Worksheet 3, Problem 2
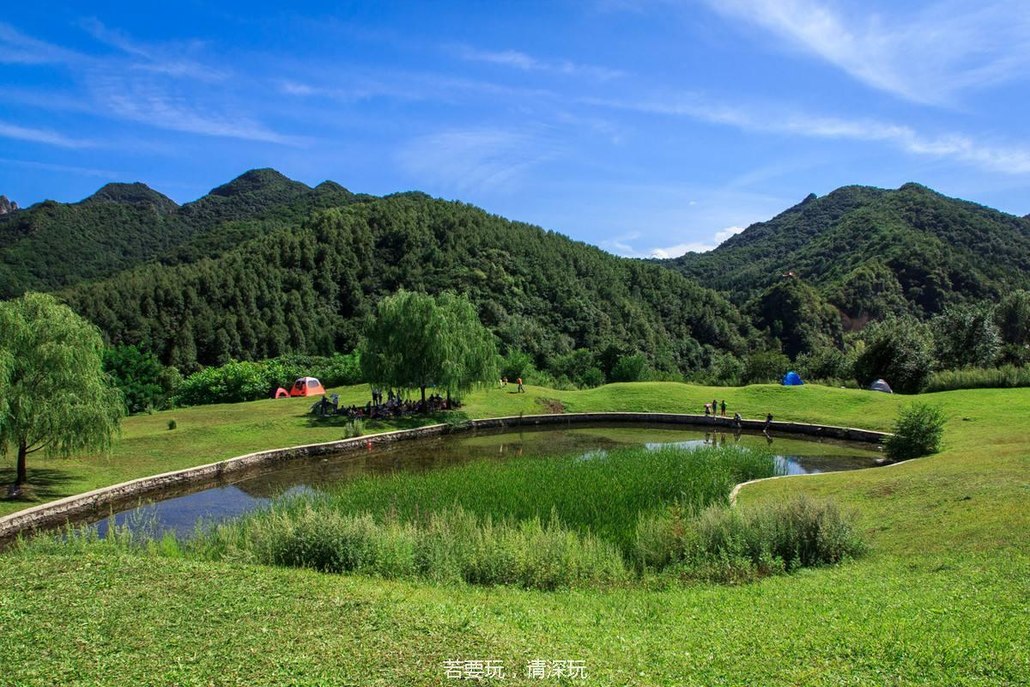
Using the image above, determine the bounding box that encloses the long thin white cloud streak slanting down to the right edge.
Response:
[585,94,1030,174]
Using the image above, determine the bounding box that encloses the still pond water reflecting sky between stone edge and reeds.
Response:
[91,424,881,537]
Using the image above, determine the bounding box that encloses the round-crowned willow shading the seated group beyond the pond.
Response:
[358,290,496,403]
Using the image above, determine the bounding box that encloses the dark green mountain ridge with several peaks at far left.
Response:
[0,170,355,298]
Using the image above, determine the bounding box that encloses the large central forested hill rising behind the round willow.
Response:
[61,194,753,371]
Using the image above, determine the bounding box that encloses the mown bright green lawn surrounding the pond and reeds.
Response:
[0,384,1030,685]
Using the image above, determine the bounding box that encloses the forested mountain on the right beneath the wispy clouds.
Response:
[663,183,1030,325]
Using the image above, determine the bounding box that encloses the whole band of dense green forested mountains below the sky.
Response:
[0,169,1030,407]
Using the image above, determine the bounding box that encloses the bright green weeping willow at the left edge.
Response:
[0,294,125,492]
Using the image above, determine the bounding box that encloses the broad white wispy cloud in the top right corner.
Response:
[706,0,1030,104]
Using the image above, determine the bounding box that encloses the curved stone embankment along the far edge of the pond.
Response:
[0,412,886,545]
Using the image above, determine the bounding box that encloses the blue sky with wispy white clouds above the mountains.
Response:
[0,0,1030,255]
